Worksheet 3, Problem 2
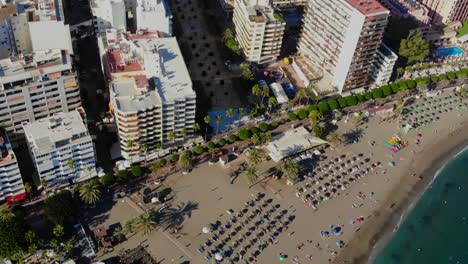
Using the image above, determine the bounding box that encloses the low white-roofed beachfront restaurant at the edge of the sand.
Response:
[267,127,327,162]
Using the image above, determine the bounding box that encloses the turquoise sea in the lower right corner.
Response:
[373,146,468,264]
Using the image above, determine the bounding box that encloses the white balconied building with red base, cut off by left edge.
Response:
[0,131,25,202]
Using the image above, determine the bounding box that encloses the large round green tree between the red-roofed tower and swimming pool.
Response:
[398,29,431,63]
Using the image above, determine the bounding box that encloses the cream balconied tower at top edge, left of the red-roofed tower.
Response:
[233,0,286,64]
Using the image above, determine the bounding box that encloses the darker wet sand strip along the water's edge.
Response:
[333,120,468,264]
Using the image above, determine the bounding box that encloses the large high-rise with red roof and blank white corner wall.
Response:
[298,0,390,93]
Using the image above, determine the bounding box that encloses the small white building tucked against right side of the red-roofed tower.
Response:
[372,43,398,86]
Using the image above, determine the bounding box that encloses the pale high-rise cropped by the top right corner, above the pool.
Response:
[417,0,468,24]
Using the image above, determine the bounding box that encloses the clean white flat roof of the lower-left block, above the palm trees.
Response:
[23,110,91,153]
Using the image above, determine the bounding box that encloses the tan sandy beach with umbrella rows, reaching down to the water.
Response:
[91,88,468,263]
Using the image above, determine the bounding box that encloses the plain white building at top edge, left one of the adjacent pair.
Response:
[90,0,127,32]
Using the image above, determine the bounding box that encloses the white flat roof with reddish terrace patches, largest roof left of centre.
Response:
[108,34,196,112]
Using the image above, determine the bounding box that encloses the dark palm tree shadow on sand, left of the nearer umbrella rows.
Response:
[157,201,198,230]
